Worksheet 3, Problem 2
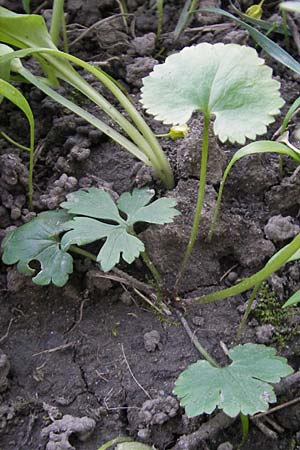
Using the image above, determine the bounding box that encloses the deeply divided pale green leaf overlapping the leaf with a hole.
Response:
[61,188,179,272]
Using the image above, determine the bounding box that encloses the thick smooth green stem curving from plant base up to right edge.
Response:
[184,234,300,305]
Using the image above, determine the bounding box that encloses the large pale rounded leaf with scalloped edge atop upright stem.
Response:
[141,43,284,144]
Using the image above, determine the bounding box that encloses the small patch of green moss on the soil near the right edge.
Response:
[253,283,299,347]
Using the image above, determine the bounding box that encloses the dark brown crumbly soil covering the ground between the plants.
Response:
[0,0,300,450]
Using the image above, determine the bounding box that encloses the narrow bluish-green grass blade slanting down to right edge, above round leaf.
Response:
[199,8,300,73]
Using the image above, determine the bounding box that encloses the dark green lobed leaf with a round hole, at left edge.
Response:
[2,211,73,287]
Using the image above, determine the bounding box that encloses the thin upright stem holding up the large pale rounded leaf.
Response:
[174,113,210,297]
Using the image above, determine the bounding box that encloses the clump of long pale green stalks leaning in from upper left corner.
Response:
[0,7,174,188]
